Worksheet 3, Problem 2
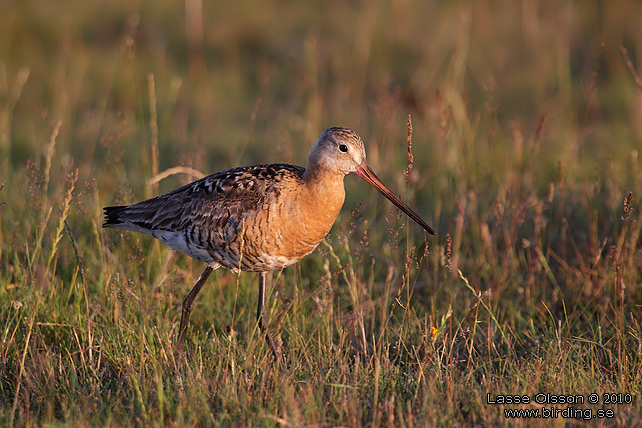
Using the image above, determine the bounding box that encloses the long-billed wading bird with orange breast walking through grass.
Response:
[102,127,435,364]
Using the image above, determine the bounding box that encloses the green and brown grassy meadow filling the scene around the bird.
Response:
[0,0,642,426]
